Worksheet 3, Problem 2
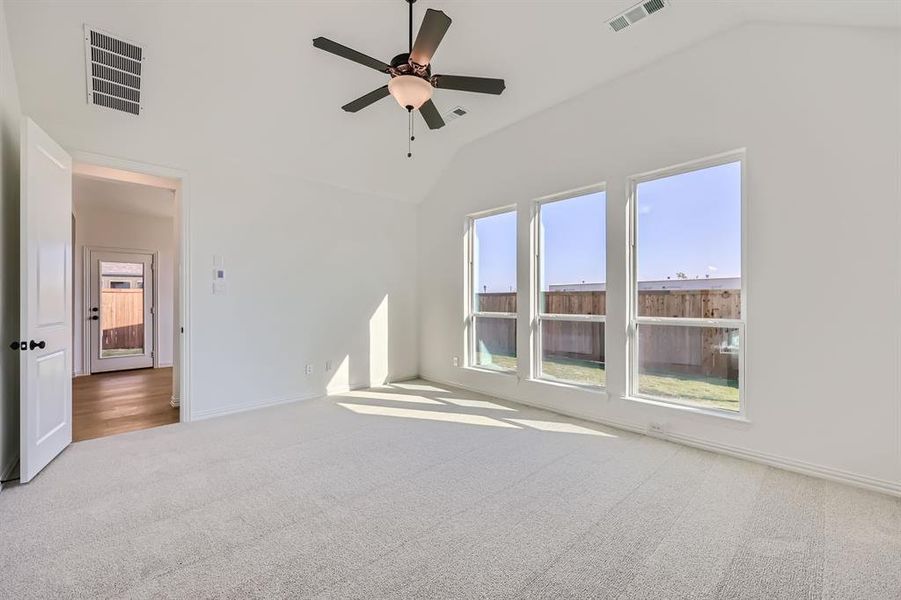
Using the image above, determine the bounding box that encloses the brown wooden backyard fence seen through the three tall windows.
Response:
[477,290,741,379]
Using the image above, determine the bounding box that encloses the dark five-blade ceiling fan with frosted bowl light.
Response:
[313,0,505,157]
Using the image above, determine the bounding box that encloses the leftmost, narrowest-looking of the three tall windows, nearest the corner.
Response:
[468,208,516,371]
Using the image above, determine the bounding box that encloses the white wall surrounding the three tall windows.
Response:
[419,24,901,491]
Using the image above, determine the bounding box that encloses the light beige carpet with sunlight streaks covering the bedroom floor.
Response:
[0,382,901,600]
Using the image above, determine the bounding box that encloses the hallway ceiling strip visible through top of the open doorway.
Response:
[72,175,175,219]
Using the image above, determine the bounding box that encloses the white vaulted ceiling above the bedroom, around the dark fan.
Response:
[6,0,901,201]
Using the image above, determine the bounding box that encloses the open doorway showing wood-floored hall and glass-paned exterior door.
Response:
[72,162,182,442]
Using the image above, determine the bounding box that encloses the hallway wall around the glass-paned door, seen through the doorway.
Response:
[73,199,175,374]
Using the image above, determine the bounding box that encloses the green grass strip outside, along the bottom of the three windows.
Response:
[479,353,738,411]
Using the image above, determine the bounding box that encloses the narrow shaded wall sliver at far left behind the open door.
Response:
[0,0,22,486]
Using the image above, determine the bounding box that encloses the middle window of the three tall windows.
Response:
[535,187,607,386]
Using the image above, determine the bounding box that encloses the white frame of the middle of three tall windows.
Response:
[531,182,609,391]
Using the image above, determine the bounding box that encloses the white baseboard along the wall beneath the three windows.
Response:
[421,374,901,497]
